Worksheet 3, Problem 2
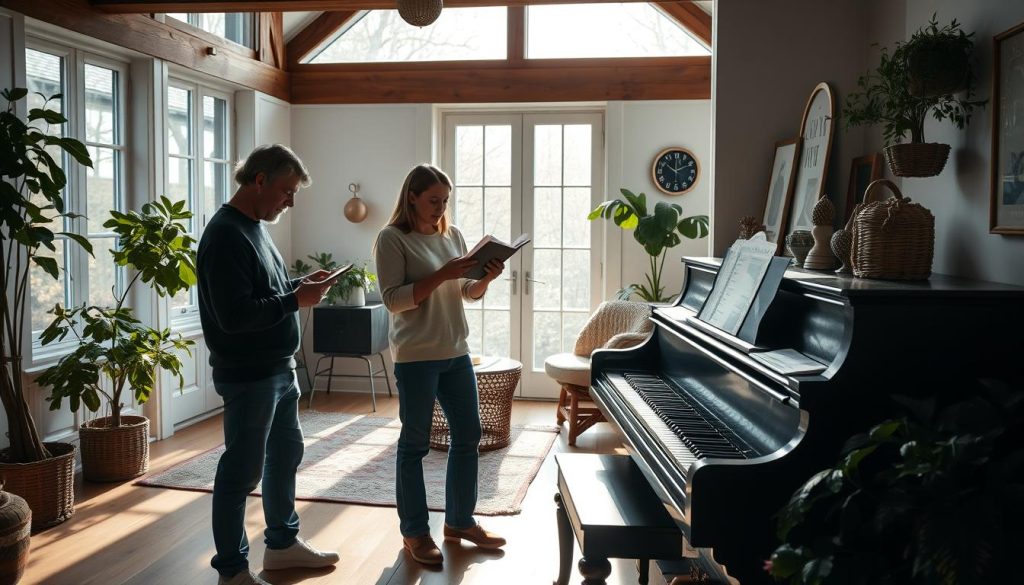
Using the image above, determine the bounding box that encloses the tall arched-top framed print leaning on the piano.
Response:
[785,82,836,235]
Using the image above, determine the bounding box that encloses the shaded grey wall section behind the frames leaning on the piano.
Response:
[712,0,869,255]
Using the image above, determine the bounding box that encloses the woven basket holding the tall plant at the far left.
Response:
[0,443,75,531]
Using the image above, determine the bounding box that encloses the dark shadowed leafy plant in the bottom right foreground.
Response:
[766,381,1024,585]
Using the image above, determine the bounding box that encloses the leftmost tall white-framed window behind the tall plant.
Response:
[26,39,127,350]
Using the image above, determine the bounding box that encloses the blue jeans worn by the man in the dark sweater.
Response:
[210,371,303,577]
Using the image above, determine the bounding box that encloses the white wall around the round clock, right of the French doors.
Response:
[604,99,712,298]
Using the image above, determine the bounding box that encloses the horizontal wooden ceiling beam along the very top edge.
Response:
[90,0,703,13]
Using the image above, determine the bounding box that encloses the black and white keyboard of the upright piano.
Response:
[605,372,755,469]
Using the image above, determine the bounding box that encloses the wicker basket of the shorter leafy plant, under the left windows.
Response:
[78,416,150,482]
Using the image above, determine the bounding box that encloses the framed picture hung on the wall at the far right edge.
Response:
[988,23,1024,236]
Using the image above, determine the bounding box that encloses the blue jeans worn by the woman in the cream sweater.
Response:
[394,356,480,536]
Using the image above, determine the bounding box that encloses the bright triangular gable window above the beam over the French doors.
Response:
[303,2,711,64]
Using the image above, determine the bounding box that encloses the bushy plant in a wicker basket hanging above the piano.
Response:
[843,18,986,177]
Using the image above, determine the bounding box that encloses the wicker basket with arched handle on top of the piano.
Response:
[850,179,935,281]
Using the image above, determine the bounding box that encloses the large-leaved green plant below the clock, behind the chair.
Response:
[587,189,709,302]
